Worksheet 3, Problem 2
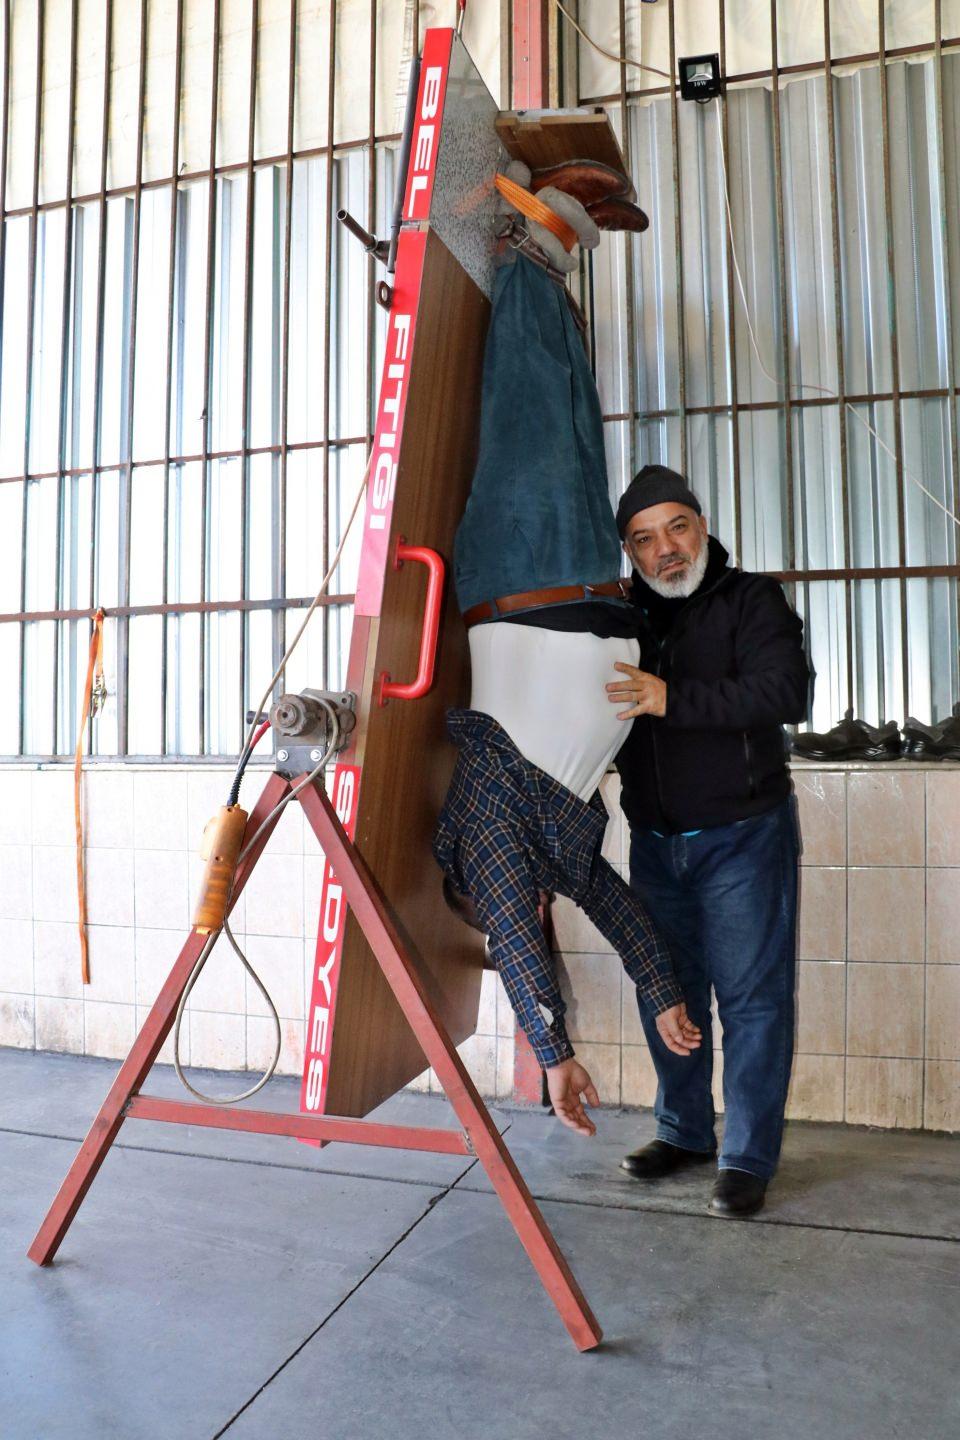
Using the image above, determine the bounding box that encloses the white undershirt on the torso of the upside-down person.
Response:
[469,621,640,801]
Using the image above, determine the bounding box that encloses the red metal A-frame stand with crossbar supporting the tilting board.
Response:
[27,775,602,1351]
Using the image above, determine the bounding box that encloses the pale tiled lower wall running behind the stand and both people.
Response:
[0,766,960,1130]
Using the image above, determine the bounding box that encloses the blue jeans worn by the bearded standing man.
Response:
[630,798,799,1179]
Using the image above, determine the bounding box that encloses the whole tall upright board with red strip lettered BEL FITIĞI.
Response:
[301,29,502,1117]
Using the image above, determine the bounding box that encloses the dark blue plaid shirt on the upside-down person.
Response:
[433,710,682,1067]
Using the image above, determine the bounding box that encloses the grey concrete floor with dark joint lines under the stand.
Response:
[0,1050,960,1440]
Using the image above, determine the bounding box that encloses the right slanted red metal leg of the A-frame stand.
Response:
[298,785,602,1351]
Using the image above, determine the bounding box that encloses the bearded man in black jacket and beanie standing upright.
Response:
[607,465,809,1215]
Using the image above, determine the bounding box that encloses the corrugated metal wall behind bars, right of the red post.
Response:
[592,32,960,729]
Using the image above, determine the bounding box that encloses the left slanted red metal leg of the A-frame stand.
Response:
[27,775,289,1264]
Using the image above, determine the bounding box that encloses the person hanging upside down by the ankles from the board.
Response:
[433,151,701,1135]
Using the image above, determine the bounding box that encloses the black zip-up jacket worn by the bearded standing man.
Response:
[616,536,810,834]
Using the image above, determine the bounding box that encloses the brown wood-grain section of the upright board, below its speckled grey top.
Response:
[315,230,489,1116]
